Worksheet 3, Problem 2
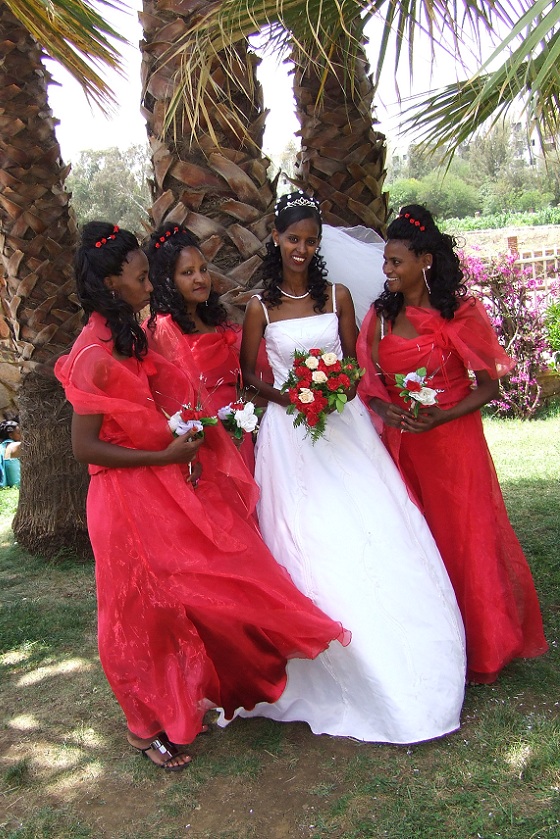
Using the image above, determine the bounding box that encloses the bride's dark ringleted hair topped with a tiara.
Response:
[261,192,328,312]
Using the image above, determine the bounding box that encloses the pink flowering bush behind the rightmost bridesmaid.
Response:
[461,253,550,419]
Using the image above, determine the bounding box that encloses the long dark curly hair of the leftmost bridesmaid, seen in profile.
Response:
[74,221,148,360]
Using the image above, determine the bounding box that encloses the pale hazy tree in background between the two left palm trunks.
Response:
[66,144,152,236]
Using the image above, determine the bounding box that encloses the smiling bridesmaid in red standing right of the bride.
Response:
[358,205,547,683]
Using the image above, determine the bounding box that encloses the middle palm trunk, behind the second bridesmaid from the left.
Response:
[140,0,275,296]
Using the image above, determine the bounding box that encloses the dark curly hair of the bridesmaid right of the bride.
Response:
[374,204,467,322]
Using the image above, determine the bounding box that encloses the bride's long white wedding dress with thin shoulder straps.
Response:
[230,290,465,743]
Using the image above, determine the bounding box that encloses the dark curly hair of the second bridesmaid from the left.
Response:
[144,222,228,335]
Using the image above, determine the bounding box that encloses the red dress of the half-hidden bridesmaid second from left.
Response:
[146,315,272,474]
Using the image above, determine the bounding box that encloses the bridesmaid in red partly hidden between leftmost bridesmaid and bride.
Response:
[145,223,272,474]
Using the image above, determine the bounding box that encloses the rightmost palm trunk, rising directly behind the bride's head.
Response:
[292,49,389,235]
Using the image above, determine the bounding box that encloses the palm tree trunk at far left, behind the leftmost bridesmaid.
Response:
[0,2,89,556]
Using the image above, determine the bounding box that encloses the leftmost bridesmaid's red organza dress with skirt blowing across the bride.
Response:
[55,315,348,743]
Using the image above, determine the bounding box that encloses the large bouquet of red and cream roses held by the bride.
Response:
[281,349,364,443]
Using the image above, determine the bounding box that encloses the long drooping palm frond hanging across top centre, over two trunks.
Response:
[158,0,516,143]
